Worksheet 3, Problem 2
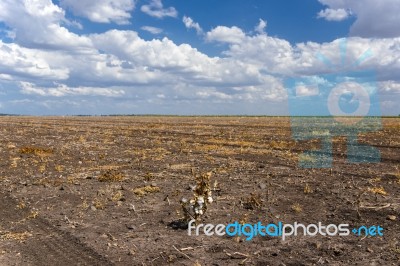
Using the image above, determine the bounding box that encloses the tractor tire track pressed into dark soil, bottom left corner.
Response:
[0,192,113,265]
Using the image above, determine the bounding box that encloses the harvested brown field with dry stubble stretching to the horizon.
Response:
[0,117,400,265]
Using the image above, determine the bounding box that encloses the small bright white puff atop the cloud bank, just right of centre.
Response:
[206,26,246,43]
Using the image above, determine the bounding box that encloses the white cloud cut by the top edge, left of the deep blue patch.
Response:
[60,0,135,24]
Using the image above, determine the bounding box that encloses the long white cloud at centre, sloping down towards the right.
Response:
[91,30,261,86]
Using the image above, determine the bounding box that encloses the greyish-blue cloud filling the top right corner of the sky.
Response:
[319,0,400,38]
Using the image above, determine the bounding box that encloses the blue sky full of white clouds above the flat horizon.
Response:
[0,0,400,115]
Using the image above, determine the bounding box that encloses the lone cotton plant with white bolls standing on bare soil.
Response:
[181,172,213,222]
